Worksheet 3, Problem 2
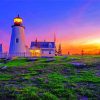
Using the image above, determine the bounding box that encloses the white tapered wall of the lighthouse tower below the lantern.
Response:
[9,26,26,54]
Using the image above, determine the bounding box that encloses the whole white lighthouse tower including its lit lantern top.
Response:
[9,15,26,56]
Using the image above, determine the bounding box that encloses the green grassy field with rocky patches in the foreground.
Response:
[0,56,100,100]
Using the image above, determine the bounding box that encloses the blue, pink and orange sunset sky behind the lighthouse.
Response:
[0,0,100,53]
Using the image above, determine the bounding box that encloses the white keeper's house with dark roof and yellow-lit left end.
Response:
[30,41,55,57]
